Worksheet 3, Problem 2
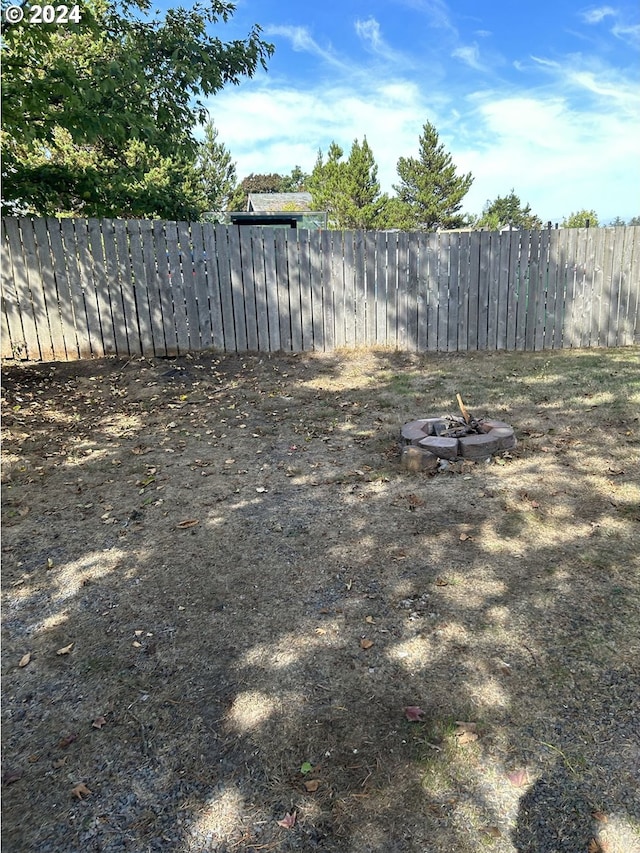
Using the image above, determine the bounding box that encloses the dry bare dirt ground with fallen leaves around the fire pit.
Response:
[2,348,640,853]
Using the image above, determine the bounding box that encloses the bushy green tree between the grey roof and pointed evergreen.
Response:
[308,137,388,230]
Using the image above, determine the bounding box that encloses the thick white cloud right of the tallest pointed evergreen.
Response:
[456,93,640,222]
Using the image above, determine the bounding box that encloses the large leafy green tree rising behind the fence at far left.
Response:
[2,0,273,218]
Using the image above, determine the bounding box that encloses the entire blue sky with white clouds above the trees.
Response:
[198,0,640,223]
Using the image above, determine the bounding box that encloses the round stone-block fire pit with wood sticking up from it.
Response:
[400,394,517,471]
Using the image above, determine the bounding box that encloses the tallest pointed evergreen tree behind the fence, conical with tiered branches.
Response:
[394,122,473,231]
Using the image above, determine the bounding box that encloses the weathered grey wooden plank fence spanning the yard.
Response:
[2,218,640,361]
